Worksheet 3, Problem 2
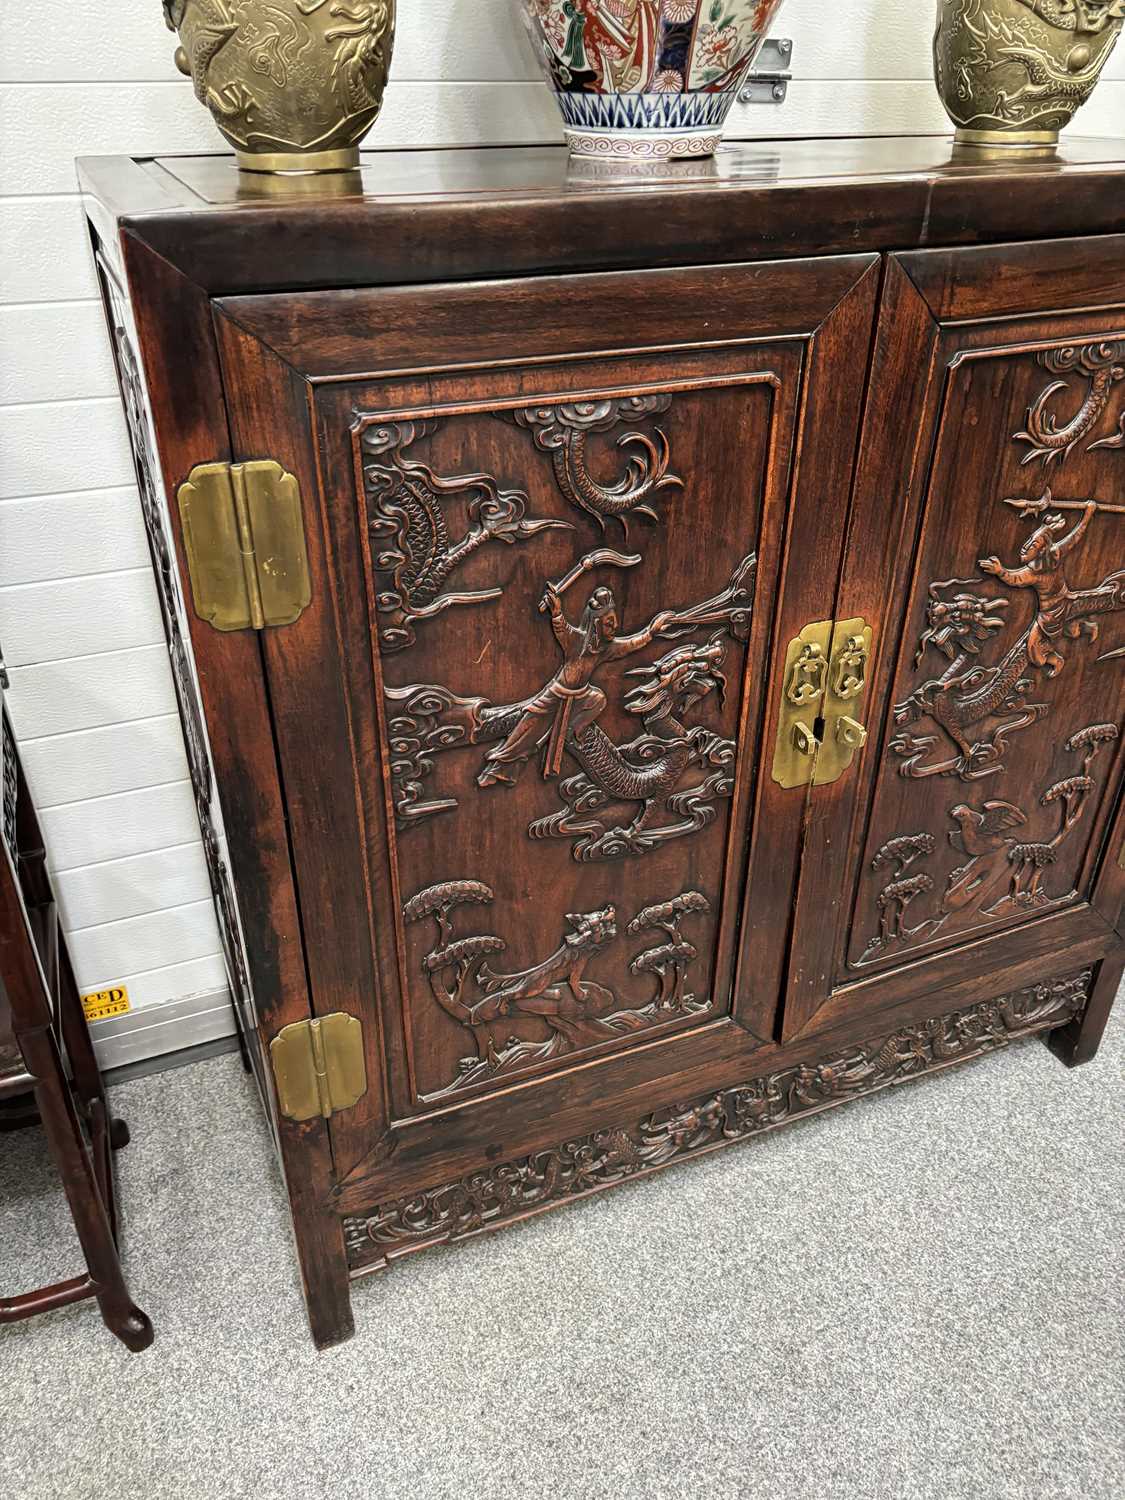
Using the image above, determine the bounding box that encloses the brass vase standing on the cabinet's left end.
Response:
[164,0,395,173]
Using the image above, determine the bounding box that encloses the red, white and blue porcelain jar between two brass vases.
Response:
[519,0,782,159]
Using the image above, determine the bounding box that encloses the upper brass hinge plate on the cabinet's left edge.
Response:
[176,459,312,630]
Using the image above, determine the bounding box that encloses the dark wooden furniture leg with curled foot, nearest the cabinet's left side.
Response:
[21,1031,153,1353]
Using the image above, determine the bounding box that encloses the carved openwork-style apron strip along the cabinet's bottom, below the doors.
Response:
[344,969,1092,1269]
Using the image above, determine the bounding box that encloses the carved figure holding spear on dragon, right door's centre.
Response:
[891,489,1125,782]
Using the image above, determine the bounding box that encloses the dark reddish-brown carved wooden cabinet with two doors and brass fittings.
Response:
[84,141,1125,1343]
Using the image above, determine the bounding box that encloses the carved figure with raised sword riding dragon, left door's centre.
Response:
[384,548,756,860]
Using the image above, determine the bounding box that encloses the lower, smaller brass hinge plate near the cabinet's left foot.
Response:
[270,1011,368,1121]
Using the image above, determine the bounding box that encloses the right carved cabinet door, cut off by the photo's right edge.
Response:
[783,237,1125,1038]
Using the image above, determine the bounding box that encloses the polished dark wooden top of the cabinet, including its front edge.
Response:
[78,135,1125,291]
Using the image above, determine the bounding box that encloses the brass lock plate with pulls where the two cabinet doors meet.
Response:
[774,620,872,788]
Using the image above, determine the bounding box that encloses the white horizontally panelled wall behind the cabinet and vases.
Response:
[0,0,1125,1047]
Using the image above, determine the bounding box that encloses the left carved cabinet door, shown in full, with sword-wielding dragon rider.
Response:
[216,257,879,1206]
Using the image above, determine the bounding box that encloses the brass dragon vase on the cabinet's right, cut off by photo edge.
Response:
[933,0,1125,150]
